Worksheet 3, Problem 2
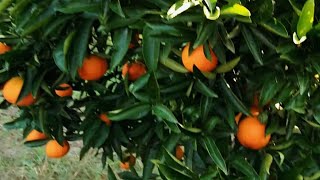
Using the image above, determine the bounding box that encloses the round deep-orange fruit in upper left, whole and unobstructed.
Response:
[78,55,108,81]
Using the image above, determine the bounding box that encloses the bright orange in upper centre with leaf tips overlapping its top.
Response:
[182,43,218,72]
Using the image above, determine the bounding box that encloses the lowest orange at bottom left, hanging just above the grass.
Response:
[46,140,70,158]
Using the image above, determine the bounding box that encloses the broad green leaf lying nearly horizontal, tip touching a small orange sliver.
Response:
[108,103,151,121]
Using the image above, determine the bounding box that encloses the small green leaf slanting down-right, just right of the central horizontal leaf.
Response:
[152,104,178,123]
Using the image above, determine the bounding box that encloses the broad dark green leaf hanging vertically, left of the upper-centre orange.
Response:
[142,26,160,71]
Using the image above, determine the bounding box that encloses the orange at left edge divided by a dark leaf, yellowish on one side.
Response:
[2,76,35,106]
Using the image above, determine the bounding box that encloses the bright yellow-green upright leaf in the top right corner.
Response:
[297,0,315,38]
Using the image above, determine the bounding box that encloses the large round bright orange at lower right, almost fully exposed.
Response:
[237,116,271,150]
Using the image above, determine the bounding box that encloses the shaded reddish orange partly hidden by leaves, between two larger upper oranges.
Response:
[122,62,147,81]
